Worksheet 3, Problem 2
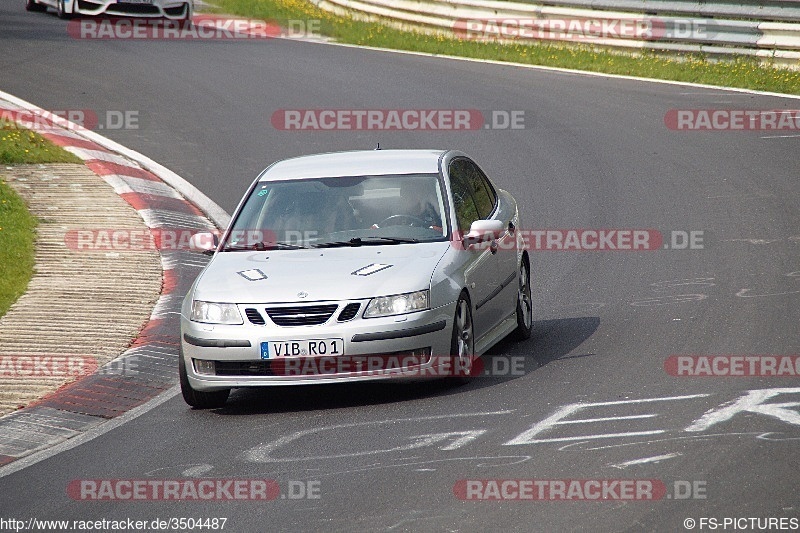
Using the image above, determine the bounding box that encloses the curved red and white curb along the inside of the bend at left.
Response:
[0,92,229,470]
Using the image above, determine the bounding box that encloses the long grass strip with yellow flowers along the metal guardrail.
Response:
[214,0,800,94]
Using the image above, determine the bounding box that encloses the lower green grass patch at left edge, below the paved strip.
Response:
[0,180,36,316]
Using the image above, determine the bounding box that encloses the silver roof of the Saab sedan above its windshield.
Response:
[259,150,446,181]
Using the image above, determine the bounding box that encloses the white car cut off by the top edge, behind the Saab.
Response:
[25,0,194,22]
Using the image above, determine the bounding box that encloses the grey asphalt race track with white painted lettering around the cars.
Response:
[0,5,800,531]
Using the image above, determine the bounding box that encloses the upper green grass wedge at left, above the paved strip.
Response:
[0,119,83,165]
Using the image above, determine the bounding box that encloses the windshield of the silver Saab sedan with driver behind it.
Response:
[223,174,447,250]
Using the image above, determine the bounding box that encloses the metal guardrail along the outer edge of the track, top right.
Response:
[311,0,800,69]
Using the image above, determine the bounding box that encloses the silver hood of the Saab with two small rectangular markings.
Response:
[193,242,450,304]
